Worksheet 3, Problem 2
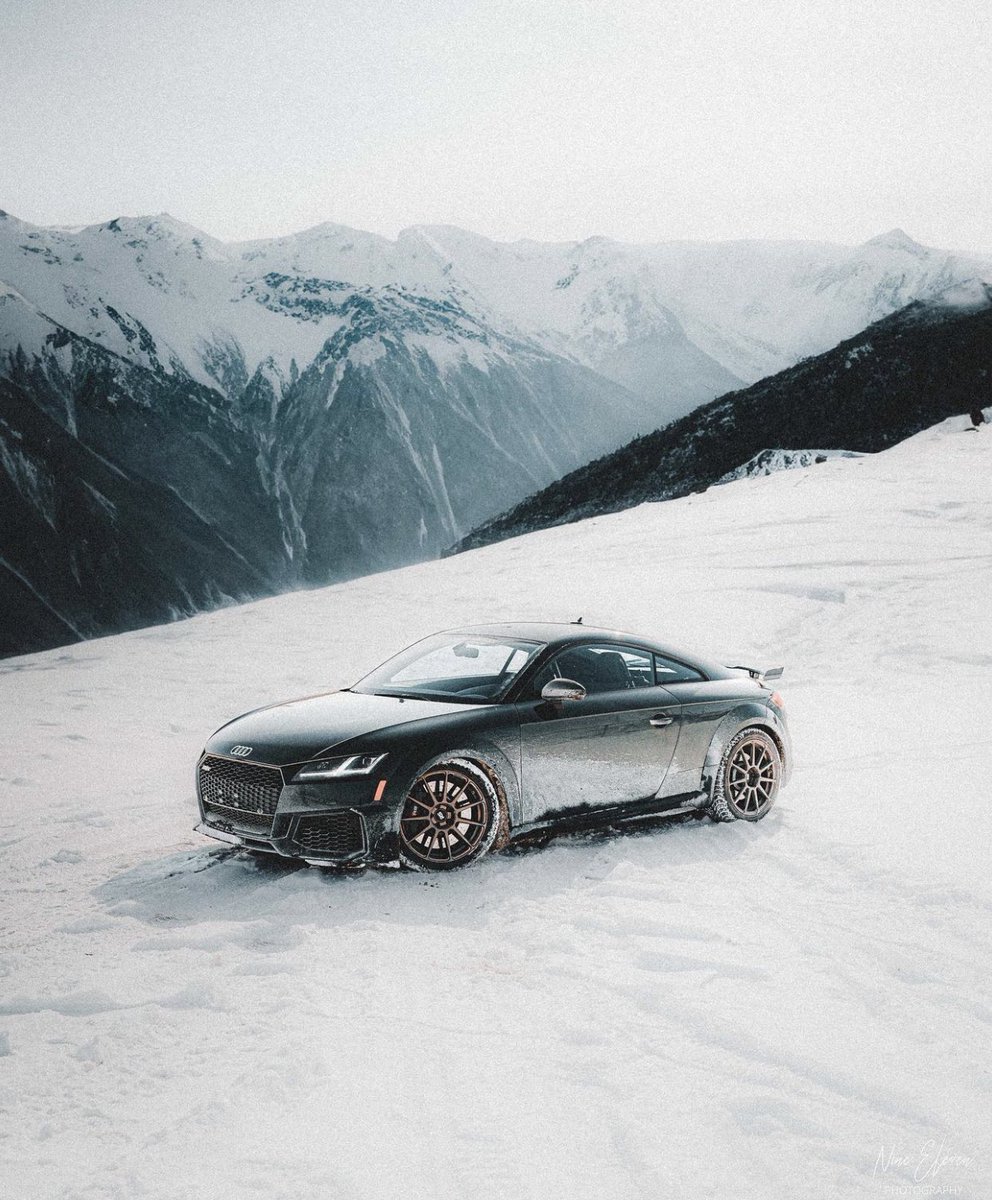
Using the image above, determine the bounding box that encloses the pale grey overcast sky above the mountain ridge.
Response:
[0,0,992,252]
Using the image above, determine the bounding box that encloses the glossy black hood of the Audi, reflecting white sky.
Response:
[200,691,476,767]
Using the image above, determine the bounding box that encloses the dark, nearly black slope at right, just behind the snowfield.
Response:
[453,282,992,551]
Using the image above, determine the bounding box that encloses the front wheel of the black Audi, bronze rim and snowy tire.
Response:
[399,758,510,871]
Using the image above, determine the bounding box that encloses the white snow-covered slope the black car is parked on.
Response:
[0,419,992,1200]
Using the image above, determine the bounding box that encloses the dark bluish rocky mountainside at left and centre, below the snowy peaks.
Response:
[0,229,653,654]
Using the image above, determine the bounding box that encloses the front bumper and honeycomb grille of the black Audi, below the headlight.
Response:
[196,754,397,865]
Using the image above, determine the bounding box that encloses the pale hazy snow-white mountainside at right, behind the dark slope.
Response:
[364,227,992,388]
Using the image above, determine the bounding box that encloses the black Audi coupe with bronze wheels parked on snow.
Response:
[197,623,792,870]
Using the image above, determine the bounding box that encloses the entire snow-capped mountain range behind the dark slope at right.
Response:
[0,214,990,654]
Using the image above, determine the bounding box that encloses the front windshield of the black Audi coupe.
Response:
[351,634,543,704]
